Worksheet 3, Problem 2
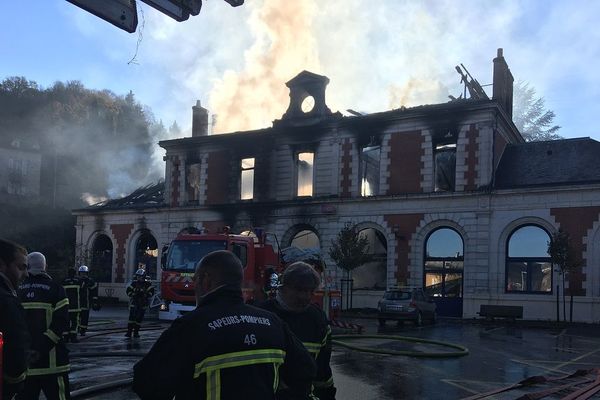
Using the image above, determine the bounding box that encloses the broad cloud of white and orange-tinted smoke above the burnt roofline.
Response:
[136,0,518,132]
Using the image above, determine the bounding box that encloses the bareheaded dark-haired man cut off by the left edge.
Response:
[0,239,30,400]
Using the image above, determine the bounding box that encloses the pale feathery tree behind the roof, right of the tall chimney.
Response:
[513,81,562,142]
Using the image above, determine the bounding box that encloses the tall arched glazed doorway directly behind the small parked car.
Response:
[423,227,464,317]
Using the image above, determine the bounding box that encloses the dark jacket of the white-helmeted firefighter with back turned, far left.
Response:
[19,273,69,375]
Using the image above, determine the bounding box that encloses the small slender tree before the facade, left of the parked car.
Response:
[329,222,373,308]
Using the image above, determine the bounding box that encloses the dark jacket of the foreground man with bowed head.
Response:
[258,299,336,400]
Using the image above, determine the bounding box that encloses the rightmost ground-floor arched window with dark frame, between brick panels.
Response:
[506,225,552,294]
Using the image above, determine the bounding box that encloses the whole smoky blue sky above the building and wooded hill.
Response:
[0,0,600,144]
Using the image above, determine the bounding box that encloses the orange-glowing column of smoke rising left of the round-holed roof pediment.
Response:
[209,0,321,133]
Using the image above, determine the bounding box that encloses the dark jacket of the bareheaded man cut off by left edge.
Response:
[0,273,31,399]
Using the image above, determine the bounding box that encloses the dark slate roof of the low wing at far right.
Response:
[494,138,600,189]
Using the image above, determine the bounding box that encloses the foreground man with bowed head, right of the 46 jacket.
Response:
[259,261,336,400]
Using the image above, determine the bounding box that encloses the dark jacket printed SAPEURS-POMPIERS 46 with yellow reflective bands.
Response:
[133,285,316,400]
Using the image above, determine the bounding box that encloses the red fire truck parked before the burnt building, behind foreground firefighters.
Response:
[159,229,341,320]
